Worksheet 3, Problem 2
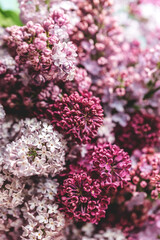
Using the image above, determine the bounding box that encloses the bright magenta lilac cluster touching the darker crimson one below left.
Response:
[81,143,131,190]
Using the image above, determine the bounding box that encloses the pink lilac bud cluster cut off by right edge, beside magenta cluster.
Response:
[130,147,160,199]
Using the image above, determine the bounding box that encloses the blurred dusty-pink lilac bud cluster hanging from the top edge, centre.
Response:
[71,0,121,71]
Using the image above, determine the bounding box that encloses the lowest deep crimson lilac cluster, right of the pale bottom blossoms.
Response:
[57,166,110,224]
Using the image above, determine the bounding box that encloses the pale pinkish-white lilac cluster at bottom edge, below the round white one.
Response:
[22,178,65,240]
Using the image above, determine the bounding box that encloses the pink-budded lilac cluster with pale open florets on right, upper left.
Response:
[5,11,77,84]
